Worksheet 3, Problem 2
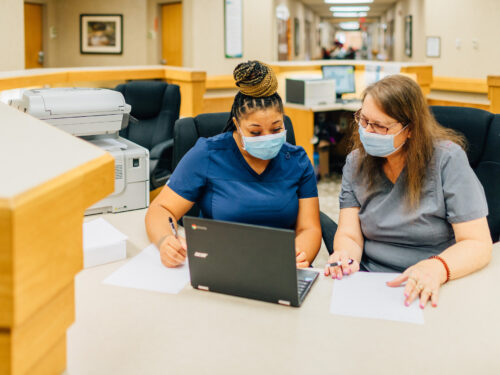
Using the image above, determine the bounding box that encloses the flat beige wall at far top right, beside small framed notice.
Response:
[424,0,500,78]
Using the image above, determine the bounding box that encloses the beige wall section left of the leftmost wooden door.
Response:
[0,0,24,70]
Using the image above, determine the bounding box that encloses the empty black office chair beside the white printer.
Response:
[115,81,181,190]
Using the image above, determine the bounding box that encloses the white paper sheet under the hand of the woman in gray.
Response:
[330,272,424,324]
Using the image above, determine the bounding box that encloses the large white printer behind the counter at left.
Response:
[10,88,149,215]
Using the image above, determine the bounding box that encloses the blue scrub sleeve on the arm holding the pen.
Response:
[167,138,209,202]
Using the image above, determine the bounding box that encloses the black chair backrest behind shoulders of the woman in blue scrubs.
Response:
[172,112,295,170]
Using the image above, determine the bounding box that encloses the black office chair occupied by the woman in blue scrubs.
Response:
[172,112,337,254]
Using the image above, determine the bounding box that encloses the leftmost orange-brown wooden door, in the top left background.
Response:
[24,3,43,69]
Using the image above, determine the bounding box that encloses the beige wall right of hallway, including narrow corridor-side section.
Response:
[382,0,500,78]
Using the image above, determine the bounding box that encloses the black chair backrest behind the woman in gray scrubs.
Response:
[430,106,500,242]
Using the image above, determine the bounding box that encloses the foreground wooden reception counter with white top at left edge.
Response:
[0,103,114,375]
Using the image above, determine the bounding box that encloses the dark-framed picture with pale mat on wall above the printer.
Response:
[80,14,123,55]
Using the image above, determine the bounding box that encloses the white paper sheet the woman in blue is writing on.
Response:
[103,245,189,294]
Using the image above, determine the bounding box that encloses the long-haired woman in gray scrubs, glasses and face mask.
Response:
[325,75,492,308]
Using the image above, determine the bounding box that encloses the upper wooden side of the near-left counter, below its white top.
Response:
[0,154,114,327]
